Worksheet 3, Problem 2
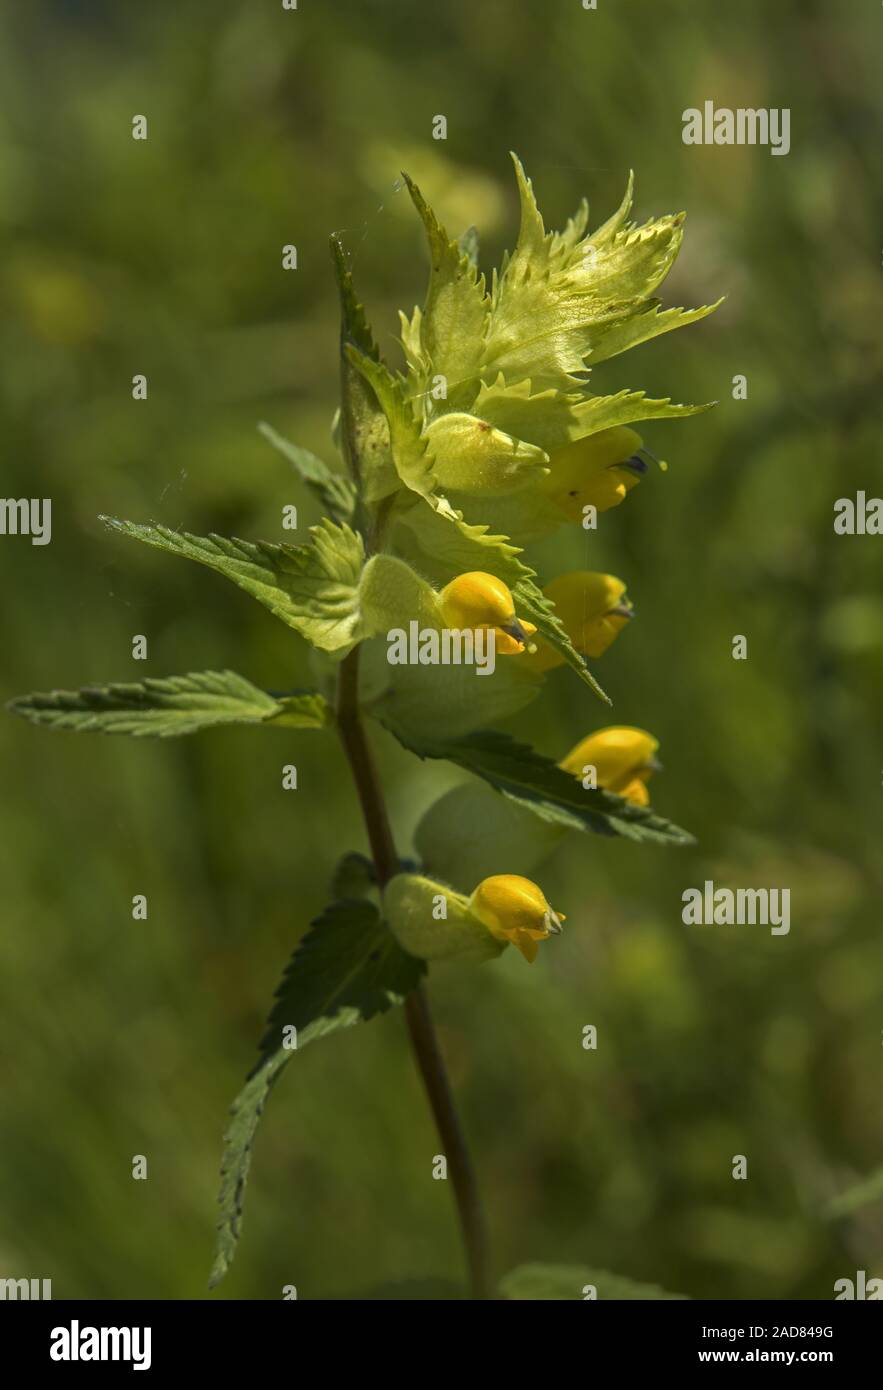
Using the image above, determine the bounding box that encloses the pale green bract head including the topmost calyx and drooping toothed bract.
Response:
[342,156,716,699]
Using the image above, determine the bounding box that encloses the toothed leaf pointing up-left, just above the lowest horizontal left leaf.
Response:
[102,517,364,653]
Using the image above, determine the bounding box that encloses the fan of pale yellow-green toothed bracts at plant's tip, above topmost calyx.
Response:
[394,156,718,458]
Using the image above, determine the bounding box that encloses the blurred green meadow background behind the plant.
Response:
[0,0,883,1298]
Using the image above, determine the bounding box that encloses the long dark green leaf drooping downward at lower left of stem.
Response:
[209,899,426,1287]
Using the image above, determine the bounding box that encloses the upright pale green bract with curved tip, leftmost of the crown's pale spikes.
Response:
[403,174,489,410]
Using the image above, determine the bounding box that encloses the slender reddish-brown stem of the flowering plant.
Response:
[337,646,491,1298]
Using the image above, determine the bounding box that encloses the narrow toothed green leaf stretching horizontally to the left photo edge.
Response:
[7,671,331,738]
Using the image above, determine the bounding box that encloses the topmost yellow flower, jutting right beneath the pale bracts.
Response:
[537,425,647,521]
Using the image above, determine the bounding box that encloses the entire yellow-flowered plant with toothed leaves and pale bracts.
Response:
[13,158,716,1297]
